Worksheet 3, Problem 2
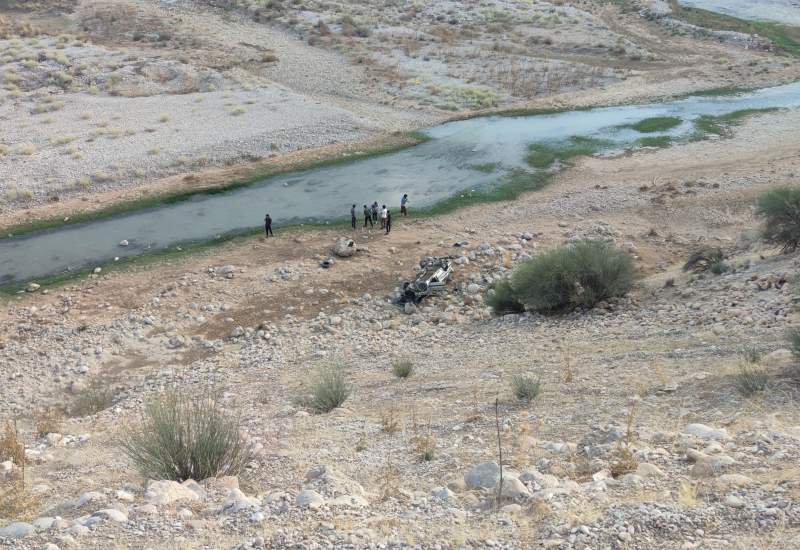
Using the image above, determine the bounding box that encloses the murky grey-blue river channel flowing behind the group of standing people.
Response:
[0,82,800,284]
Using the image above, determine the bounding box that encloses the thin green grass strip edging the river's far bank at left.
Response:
[0,132,431,239]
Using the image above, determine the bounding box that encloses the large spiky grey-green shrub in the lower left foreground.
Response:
[120,391,251,481]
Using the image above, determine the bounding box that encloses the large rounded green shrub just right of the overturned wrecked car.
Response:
[511,241,634,313]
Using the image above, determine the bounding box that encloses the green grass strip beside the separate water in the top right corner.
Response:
[670,0,800,57]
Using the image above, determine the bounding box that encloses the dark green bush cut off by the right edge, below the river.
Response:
[757,187,800,252]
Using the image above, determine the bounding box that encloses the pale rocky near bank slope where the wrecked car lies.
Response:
[0,112,800,548]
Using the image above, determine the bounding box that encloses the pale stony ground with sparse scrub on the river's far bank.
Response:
[0,0,800,216]
